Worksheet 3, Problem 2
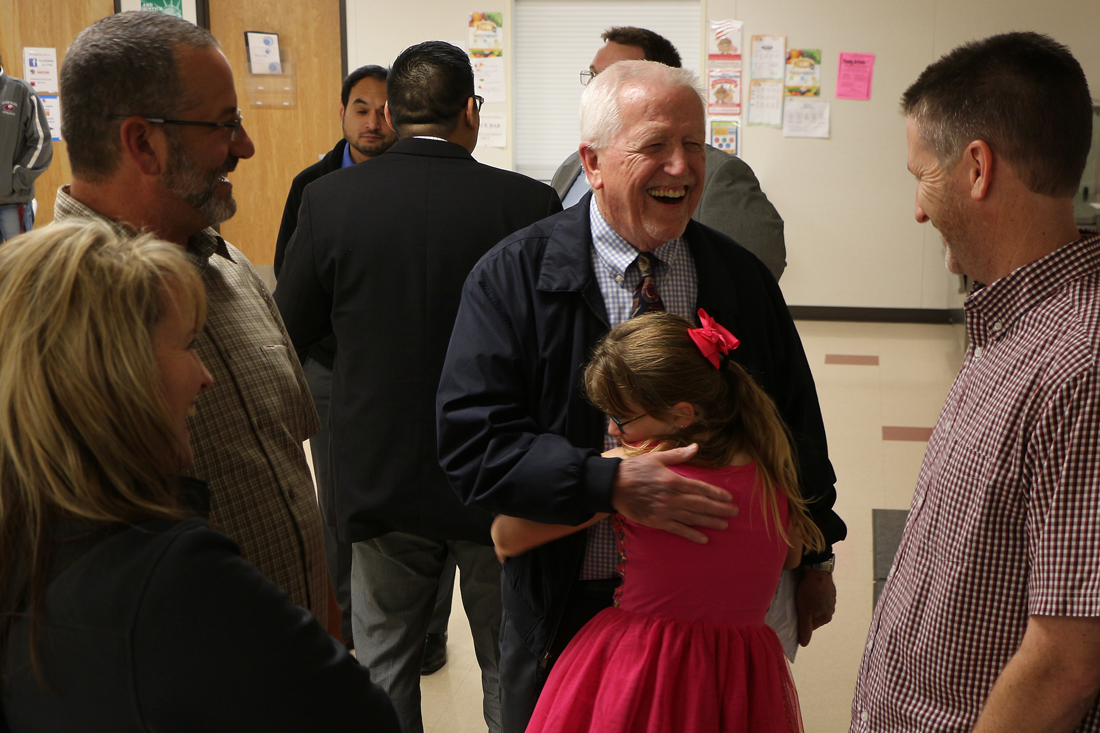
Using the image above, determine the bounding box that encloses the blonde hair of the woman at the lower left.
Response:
[0,217,206,658]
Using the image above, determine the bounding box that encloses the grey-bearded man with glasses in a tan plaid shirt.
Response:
[55,12,340,638]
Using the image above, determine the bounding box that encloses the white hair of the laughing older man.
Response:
[581,61,706,150]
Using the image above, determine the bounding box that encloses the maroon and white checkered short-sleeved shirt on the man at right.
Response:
[851,232,1100,733]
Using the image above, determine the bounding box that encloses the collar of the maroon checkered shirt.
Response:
[963,229,1100,346]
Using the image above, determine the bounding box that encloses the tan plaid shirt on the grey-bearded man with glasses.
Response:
[54,186,329,625]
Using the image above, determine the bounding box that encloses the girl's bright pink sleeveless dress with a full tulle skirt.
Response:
[527,464,802,733]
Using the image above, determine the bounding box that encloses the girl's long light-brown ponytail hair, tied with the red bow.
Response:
[584,313,825,551]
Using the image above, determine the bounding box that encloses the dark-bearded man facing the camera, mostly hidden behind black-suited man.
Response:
[275,59,398,647]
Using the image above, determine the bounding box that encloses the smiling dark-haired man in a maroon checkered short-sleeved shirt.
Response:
[851,33,1100,733]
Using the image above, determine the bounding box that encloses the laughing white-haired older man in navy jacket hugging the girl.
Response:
[438,61,846,733]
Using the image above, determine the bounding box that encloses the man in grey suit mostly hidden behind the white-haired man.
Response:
[550,26,787,281]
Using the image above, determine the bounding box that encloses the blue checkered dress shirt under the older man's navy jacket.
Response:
[581,196,699,580]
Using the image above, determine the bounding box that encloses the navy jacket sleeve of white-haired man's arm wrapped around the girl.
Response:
[437,248,619,525]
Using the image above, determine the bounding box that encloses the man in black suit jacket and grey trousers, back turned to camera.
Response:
[276,42,561,733]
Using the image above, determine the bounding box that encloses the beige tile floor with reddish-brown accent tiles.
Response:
[314,321,965,733]
